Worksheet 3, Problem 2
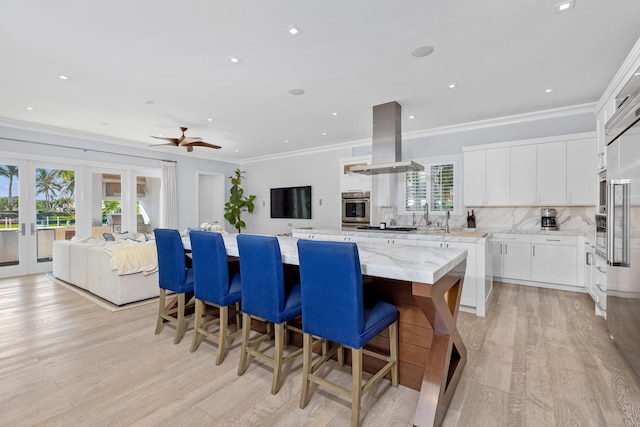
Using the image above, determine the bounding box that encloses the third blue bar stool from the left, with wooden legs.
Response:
[237,234,303,394]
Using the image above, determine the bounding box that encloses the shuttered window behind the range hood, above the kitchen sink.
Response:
[404,162,459,212]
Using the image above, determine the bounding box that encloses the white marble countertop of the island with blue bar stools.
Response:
[188,234,467,284]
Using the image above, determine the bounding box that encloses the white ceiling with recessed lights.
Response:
[0,0,640,160]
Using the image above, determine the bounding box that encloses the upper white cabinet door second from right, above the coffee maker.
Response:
[537,141,568,206]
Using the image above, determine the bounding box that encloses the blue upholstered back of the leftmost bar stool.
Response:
[154,228,193,293]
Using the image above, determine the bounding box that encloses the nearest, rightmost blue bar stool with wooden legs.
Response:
[298,240,398,426]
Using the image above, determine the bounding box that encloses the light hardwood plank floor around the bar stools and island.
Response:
[0,275,640,426]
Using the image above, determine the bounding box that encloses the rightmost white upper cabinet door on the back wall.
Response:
[567,138,598,206]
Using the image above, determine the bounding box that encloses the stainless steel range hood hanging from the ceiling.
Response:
[350,101,424,175]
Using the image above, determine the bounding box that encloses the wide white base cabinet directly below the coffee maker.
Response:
[531,236,578,286]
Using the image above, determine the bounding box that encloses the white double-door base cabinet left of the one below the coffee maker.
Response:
[491,233,531,280]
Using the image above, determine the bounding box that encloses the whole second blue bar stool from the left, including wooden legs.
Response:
[189,231,242,365]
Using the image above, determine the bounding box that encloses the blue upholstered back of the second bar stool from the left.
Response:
[189,231,230,306]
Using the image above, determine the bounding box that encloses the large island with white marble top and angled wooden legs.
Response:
[215,234,467,426]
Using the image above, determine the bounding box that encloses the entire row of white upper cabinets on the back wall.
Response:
[463,134,597,207]
